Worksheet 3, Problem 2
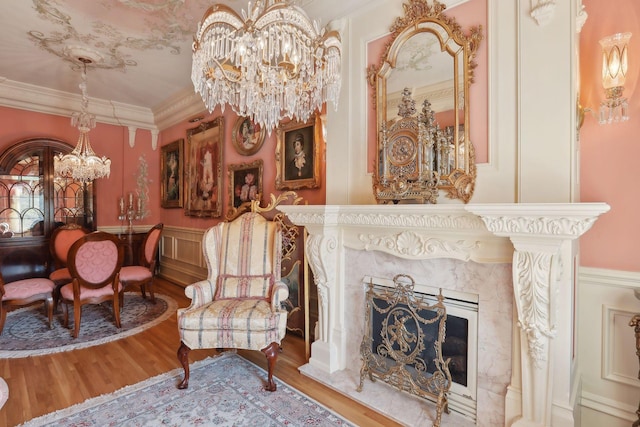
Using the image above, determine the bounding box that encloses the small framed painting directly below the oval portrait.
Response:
[227,159,264,216]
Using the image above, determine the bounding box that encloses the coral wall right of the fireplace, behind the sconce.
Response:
[580,0,640,271]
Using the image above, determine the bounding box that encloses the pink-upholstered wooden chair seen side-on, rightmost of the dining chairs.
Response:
[120,223,163,308]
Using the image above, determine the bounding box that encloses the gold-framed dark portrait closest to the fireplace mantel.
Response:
[276,114,322,190]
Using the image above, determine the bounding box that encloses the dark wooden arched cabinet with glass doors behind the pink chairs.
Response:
[0,138,96,282]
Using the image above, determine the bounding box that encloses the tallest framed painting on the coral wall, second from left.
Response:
[184,117,224,218]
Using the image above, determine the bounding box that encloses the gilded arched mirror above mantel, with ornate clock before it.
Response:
[367,0,482,203]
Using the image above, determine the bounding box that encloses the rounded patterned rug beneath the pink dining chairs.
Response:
[0,292,178,358]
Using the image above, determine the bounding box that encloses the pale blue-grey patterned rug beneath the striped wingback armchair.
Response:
[18,351,353,427]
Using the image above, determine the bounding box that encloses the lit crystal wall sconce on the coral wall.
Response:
[600,33,631,124]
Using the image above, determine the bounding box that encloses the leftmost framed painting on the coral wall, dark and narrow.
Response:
[160,139,184,208]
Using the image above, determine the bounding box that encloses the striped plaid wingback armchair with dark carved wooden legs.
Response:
[178,213,289,391]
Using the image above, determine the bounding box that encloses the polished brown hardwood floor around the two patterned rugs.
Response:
[0,279,400,427]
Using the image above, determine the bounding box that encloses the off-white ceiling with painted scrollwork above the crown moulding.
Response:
[0,0,371,109]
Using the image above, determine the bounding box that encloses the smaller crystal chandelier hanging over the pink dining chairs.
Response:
[54,58,111,183]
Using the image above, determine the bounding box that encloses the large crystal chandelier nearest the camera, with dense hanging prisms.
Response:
[191,0,341,132]
